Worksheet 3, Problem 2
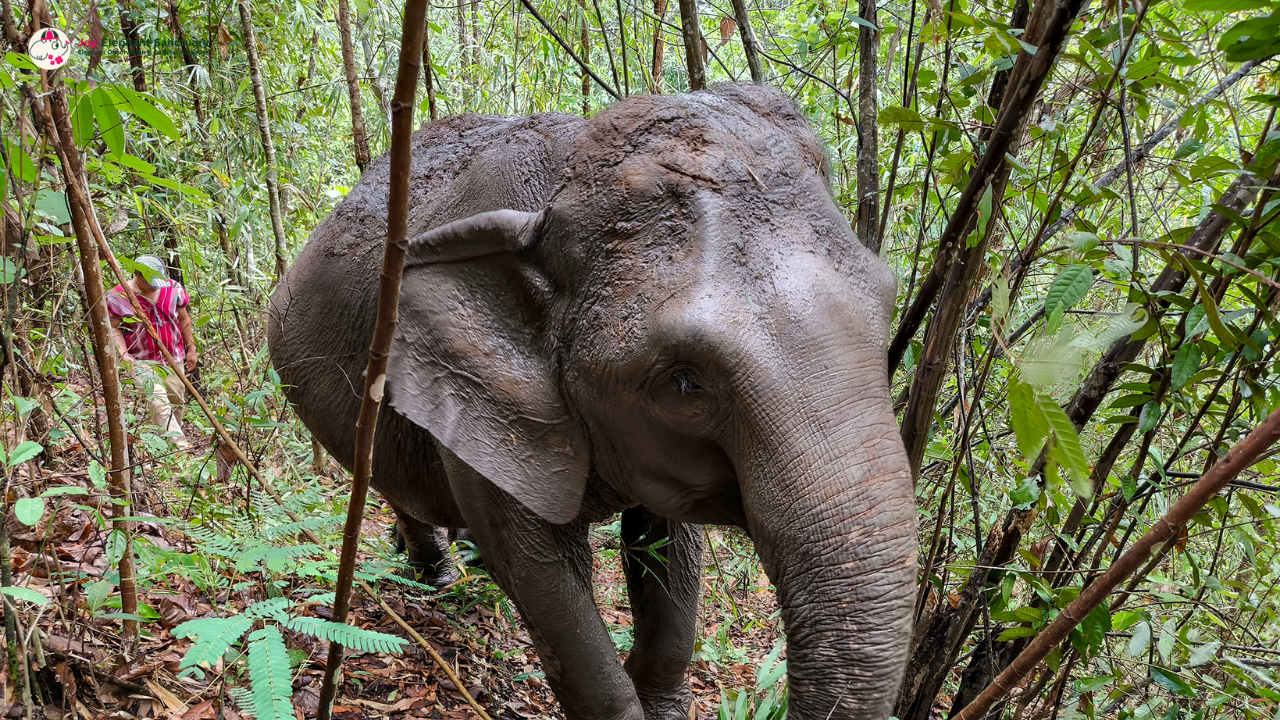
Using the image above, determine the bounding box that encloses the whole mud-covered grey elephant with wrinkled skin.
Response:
[269,86,915,720]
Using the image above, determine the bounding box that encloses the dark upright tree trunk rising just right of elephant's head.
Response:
[855,0,881,254]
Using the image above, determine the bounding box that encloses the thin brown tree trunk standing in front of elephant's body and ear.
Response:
[317,0,428,720]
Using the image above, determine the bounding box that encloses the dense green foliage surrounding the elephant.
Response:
[0,0,1280,720]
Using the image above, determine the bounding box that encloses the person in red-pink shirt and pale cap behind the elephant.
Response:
[106,255,200,451]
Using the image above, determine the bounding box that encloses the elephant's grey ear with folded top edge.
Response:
[388,210,588,523]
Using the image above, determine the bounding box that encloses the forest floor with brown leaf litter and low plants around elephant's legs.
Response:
[0,387,781,720]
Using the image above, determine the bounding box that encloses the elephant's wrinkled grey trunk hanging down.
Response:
[739,357,916,720]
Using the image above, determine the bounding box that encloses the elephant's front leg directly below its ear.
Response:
[444,452,644,720]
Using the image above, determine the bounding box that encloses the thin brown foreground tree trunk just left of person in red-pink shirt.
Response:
[44,87,138,655]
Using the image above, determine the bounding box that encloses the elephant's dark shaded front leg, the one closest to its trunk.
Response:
[622,506,703,720]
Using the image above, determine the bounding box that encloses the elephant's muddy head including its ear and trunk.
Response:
[390,86,915,720]
